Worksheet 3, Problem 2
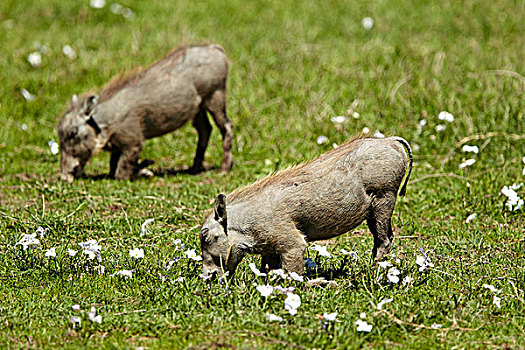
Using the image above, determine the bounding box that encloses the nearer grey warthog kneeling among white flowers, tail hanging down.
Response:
[200,137,412,275]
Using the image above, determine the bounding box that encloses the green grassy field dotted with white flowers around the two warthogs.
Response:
[0,0,525,349]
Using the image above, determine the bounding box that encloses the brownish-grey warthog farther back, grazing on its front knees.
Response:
[58,44,233,181]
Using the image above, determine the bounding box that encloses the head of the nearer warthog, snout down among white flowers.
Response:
[200,194,251,276]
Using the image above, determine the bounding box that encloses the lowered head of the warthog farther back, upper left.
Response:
[58,95,100,181]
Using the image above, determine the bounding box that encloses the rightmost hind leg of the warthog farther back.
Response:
[206,90,233,172]
